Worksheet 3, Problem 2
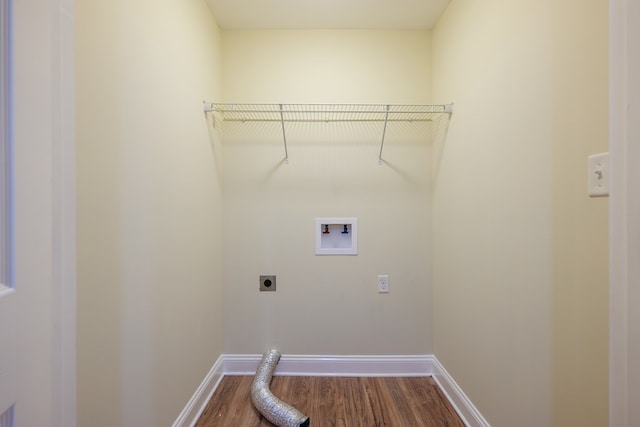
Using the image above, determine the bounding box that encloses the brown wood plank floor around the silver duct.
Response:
[196,376,464,427]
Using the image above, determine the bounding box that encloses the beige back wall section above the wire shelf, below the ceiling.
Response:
[222,30,431,104]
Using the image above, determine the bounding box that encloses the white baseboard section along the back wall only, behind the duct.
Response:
[224,354,433,377]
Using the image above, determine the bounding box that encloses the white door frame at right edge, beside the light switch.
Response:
[609,0,640,427]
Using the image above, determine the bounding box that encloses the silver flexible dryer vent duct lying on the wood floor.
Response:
[251,349,309,427]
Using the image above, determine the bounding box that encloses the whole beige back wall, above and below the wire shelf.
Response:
[222,31,433,354]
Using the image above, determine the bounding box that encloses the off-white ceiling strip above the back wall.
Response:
[207,0,449,29]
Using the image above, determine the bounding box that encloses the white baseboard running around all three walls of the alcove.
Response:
[173,354,491,427]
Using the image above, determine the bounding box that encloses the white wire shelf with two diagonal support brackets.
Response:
[204,102,453,164]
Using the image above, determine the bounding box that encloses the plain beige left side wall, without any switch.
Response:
[76,0,222,426]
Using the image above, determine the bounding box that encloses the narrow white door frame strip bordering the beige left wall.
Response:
[49,0,76,427]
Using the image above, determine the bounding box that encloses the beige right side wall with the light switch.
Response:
[433,0,608,427]
